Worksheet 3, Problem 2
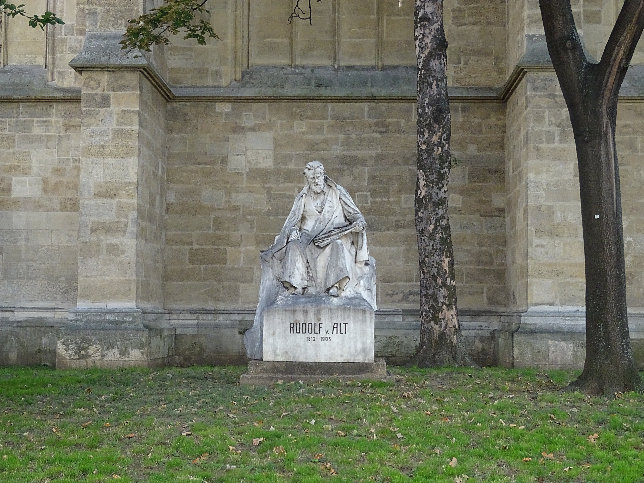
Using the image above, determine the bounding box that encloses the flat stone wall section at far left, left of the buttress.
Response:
[0,102,80,306]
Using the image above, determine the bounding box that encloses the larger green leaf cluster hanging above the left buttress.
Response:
[120,0,219,52]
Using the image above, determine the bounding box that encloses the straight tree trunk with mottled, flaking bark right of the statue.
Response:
[414,0,463,367]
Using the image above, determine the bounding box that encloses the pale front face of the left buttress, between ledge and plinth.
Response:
[78,71,140,307]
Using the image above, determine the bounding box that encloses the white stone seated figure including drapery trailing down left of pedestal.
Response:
[244,161,376,359]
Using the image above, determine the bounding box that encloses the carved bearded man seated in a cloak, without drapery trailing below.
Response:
[262,161,369,297]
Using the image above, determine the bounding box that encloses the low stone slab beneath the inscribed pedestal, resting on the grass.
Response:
[239,359,395,386]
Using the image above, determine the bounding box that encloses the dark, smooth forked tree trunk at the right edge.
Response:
[539,0,644,394]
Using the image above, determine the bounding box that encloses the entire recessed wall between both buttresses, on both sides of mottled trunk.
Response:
[165,102,506,309]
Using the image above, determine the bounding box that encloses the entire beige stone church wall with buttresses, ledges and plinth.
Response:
[0,0,644,368]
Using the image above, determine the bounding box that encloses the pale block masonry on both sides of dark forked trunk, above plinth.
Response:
[506,72,644,309]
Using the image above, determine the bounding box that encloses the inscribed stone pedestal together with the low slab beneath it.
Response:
[240,295,393,384]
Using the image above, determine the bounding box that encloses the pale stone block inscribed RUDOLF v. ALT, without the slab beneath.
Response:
[263,296,374,362]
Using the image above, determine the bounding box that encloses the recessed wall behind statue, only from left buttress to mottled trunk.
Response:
[165,102,417,308]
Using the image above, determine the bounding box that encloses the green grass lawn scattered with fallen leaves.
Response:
[0,367,644,482]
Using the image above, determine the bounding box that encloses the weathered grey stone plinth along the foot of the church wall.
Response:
[0,307,644,370]
